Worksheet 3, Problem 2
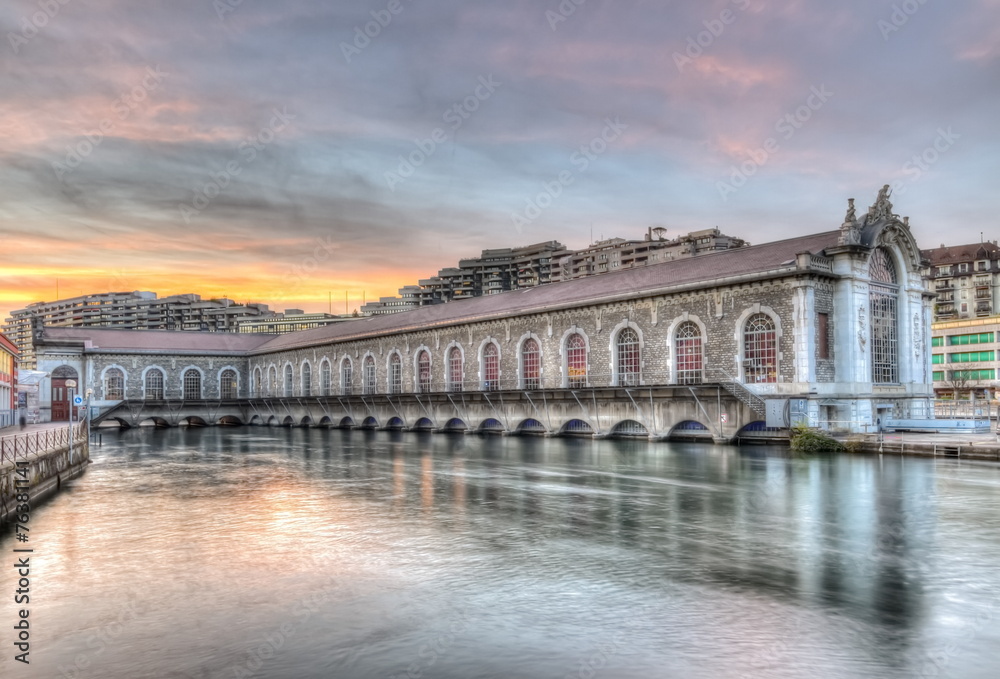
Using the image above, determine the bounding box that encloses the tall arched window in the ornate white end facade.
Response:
[868,248,899,384]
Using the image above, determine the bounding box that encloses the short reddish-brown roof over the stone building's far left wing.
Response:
[42,327,274,354]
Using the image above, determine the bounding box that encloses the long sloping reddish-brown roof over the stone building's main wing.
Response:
[250,231,840,354]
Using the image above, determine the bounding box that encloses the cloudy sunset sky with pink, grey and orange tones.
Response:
[0,0,1000,318]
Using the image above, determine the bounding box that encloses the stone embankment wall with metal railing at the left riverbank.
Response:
[0,427,90,524]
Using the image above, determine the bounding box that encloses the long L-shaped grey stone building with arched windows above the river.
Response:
[36,188,933,440]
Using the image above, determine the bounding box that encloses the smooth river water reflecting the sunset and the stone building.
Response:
[0,428,1000,679]
